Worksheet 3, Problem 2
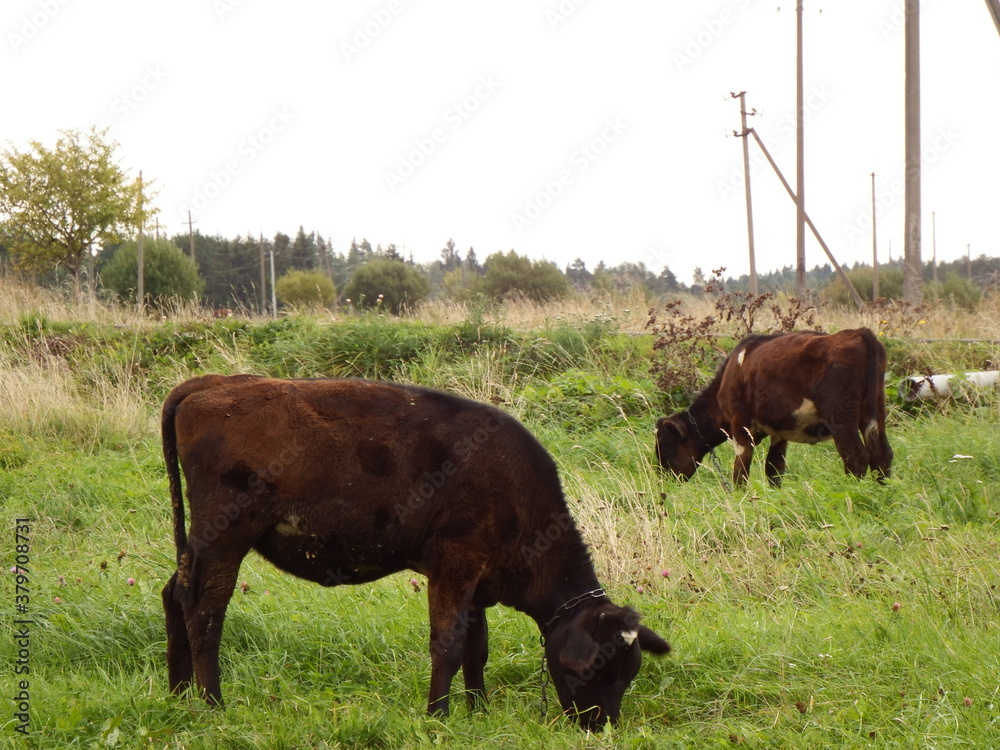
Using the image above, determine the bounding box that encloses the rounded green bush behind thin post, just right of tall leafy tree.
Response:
[101,239,205,307]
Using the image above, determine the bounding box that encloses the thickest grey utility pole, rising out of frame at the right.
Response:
[903,0,922,305]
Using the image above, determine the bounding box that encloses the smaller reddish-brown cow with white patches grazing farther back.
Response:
[656,328,892,485]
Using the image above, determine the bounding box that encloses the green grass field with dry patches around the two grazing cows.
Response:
[0,287,1000,749]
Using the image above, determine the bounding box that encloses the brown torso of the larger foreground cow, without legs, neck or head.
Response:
[168,376,565,585]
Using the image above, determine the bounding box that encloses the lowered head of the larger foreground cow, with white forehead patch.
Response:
[545,602,670,730]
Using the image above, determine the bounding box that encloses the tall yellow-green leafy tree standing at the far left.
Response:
[0,128,152,296]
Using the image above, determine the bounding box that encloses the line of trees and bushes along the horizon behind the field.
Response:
[0,128,1000,312]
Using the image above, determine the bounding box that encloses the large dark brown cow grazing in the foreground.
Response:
[162,375,670,728]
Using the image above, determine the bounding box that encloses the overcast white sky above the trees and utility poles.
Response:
[0,0,1000,282]
